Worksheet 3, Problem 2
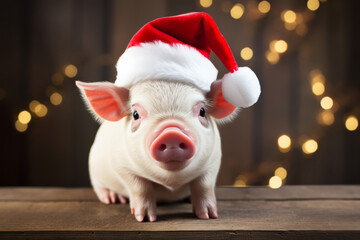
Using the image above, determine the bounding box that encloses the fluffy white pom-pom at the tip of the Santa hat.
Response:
[222,67,261,108]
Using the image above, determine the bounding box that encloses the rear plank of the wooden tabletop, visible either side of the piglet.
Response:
[0,185,360,201]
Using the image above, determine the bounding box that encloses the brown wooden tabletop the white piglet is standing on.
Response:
[0,185,360,239]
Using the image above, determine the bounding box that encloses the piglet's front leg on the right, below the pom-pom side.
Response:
[190,174,218,220]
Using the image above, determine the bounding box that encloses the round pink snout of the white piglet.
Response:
[150,126,195,170]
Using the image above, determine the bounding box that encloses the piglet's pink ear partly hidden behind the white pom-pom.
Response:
[206,80,236,120]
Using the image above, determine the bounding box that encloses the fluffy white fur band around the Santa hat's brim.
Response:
[115,41,218,92]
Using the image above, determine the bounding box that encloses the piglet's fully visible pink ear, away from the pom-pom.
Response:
[76,81,129,121]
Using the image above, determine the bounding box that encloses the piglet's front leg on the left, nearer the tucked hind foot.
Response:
[129,176,156,222]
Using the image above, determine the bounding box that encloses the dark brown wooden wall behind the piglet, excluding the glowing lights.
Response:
[0,0,360,186]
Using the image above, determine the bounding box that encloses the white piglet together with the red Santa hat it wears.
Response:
[76,13,260,222]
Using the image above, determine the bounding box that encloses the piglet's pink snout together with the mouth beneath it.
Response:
[150,121,195,171]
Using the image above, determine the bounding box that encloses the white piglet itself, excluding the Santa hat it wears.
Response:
[76,80,235,222]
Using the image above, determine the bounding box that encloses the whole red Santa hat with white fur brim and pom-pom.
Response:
[115,13,260,107]
